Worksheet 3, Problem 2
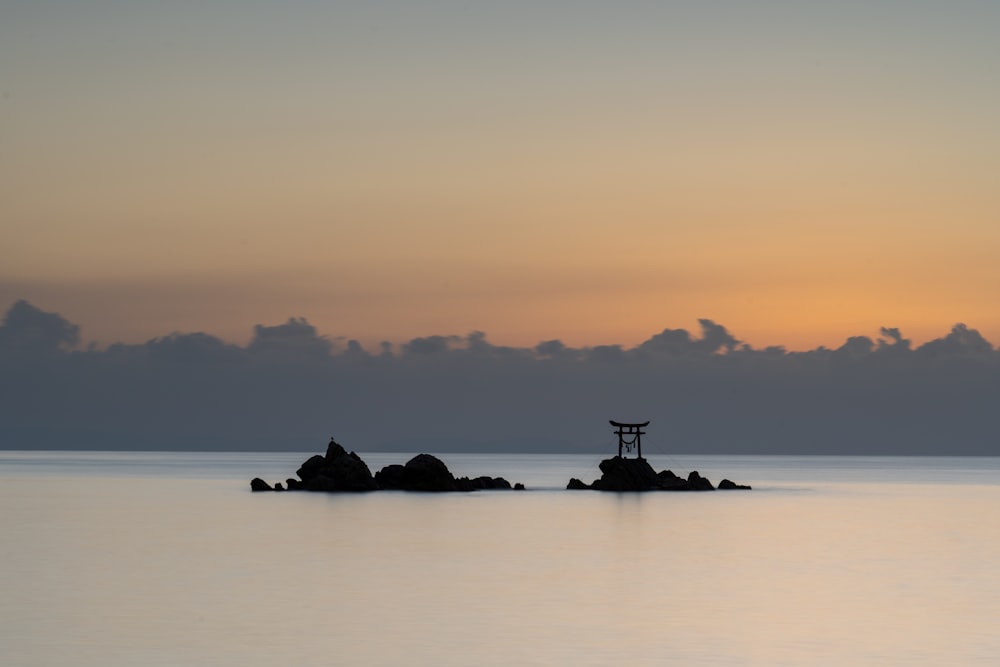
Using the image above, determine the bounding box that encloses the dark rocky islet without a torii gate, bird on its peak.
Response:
[250,439,524,493]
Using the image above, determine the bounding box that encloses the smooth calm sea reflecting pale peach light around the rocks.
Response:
[0,452,1000,667]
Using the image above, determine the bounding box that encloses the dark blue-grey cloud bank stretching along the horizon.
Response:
[0,301,1000,455]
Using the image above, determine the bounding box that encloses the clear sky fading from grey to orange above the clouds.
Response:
[0,0,1000,349]
